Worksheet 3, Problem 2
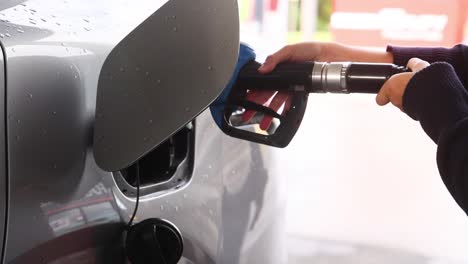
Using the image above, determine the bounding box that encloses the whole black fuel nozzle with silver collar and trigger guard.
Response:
[217,60,409,148]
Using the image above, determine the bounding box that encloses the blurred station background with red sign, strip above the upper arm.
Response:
[239,0,468,46]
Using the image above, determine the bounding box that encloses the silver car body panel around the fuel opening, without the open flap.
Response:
[0,0,286,263]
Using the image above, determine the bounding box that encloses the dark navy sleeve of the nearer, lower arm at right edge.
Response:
[403,62,468,214]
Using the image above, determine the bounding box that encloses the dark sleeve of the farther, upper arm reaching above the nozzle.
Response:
[387,44,468,87]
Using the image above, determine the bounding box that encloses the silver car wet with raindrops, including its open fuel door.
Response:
[0,0,287,264]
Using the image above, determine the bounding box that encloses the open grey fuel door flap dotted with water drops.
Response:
[94,0,239,171]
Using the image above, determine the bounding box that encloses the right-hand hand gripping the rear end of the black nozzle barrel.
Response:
[375,58,430,111]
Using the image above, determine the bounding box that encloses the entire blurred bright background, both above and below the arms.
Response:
[239,0,468,264]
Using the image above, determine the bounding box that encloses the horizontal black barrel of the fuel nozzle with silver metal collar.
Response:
[236,61,408,93]
